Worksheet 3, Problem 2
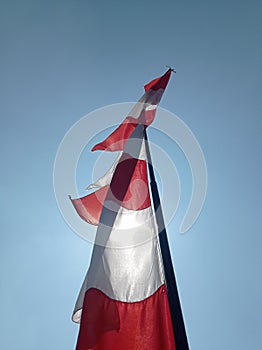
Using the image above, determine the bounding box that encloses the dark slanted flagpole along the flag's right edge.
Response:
[145,130,189,350]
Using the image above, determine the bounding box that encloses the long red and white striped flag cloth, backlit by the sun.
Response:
[71,69,176,350]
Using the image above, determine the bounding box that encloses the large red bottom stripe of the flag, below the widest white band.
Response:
[76,285,176,350]
